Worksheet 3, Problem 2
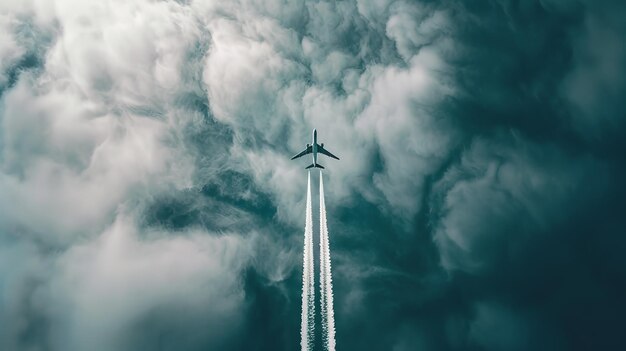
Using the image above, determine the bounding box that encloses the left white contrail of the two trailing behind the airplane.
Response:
[300,172,315,351]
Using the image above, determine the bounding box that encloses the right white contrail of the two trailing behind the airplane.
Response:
[320,171,335,351]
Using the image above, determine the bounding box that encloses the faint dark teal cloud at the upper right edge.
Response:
[563,3,626,145]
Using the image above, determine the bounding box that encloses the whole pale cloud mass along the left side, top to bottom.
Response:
[0,1,258,350]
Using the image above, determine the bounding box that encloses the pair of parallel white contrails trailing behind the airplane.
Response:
[300,172,335,351]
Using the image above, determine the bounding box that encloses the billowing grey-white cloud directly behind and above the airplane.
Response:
[197,3,457,223]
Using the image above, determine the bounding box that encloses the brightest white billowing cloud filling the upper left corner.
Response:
[0,1,201,244]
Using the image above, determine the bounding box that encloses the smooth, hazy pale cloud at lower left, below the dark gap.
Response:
[48,216,254,350]
